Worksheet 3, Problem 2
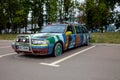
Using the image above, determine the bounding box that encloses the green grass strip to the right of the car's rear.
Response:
[91,32,120,44]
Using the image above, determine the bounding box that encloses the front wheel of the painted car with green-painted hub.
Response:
[53,43,62,57]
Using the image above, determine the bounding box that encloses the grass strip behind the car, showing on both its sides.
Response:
[0,32,120,44]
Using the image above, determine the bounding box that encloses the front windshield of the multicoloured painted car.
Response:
[39,25,66,33]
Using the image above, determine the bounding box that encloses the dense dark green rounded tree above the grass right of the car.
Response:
[86,0,110,28]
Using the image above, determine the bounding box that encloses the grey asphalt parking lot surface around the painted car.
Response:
[0,40,120,80]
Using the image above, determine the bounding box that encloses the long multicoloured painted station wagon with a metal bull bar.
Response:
[12,24,90,57]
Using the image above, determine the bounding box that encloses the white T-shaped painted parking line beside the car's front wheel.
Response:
[40,46,95,67]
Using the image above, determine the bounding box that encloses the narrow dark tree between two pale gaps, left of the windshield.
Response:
[31,0,44,32]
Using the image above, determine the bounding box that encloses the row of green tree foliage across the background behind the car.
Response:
[0,0,120,33]
